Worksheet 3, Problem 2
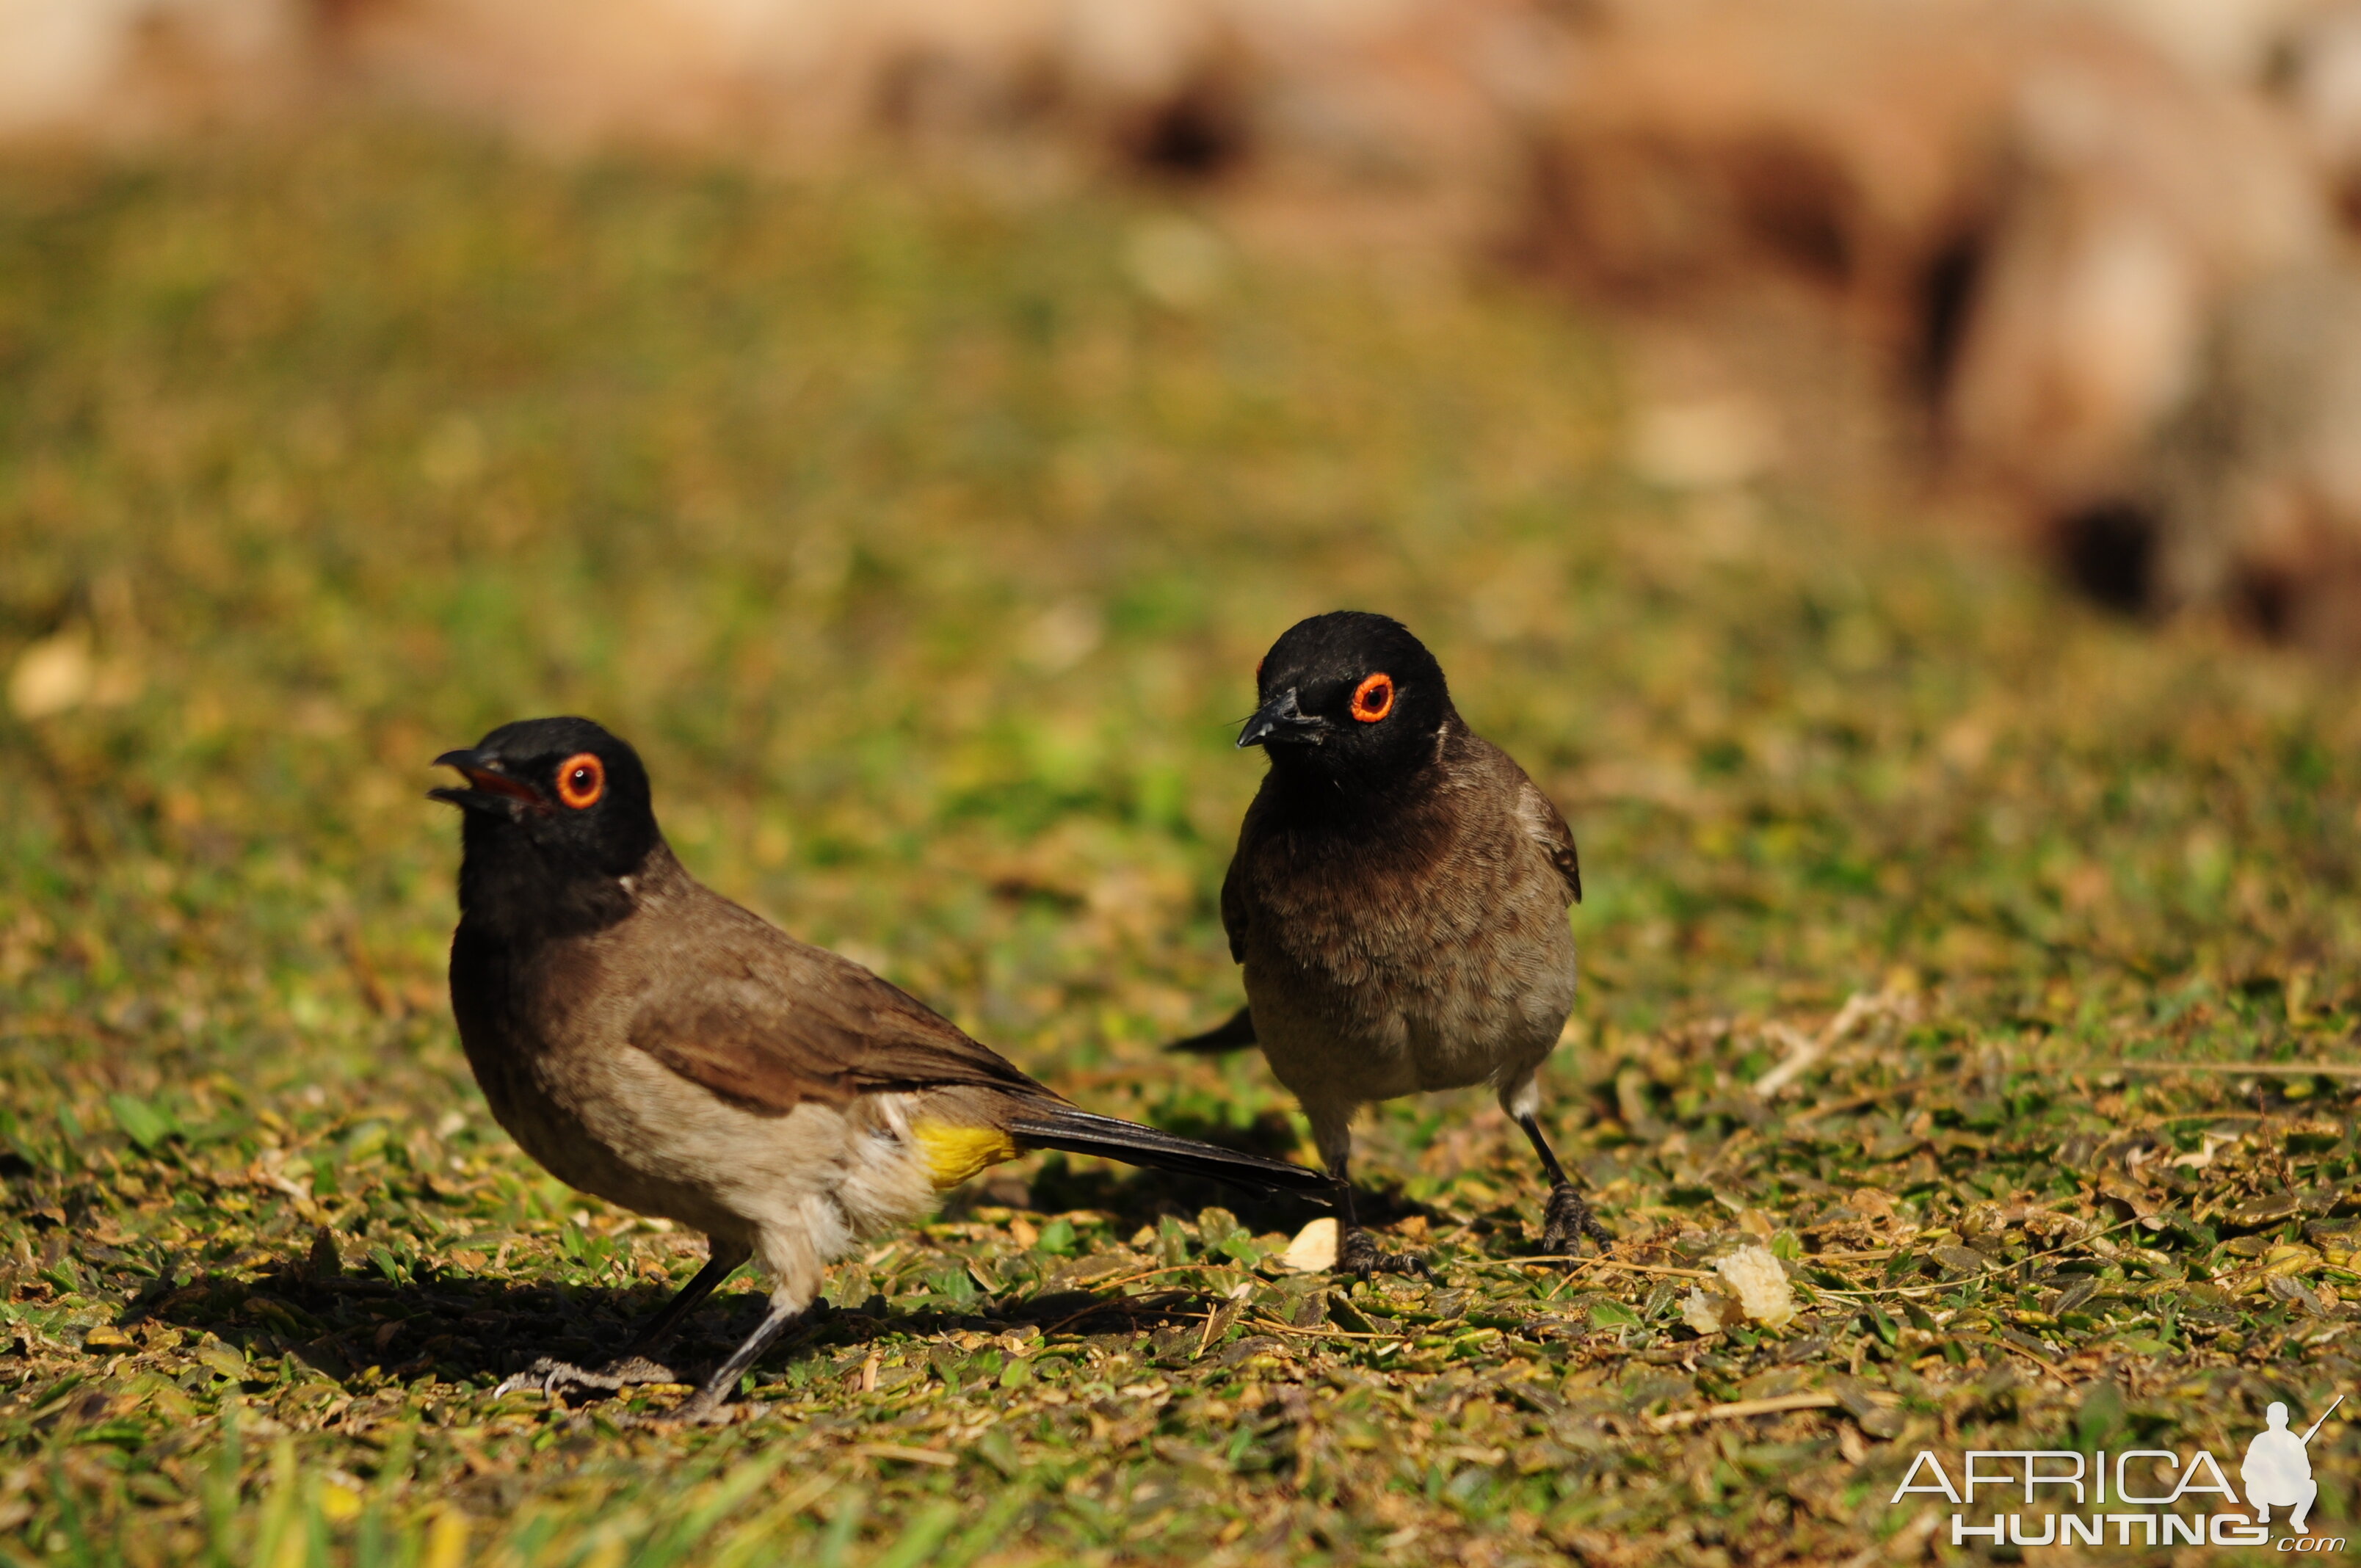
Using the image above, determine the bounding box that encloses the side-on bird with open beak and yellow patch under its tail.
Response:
[427,718,1327,1424]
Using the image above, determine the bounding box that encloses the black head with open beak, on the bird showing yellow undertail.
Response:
[427,718,664,923]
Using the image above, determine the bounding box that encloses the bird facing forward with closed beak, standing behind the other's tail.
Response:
[1169,609,1610,1277]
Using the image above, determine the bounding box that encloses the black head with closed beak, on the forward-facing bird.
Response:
[1237,609,1457,788]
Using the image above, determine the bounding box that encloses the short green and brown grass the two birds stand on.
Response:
[0,125,2361,1568]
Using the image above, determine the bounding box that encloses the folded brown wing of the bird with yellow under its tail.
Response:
[628,895,1058,1114]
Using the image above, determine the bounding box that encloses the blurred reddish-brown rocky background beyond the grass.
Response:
[0,0,2361,654]
